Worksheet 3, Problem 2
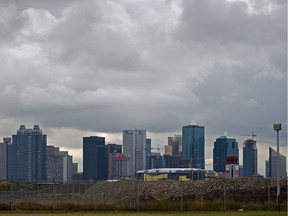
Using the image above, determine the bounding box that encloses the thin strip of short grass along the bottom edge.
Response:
[0,211,287,216]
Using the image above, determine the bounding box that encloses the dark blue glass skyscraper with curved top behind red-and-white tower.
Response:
[213,136,239,173]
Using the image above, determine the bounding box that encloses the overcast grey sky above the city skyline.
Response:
[0,0,287,174]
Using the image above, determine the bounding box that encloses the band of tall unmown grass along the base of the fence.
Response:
[0,200,287,213]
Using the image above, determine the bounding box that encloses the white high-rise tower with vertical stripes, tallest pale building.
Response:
[123,129,147,176]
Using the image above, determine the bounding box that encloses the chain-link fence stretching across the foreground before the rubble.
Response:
[0,178,287,211]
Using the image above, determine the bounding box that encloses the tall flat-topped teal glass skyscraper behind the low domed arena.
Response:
[182,125,205,169]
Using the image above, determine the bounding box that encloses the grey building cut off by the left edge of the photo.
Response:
[0,137,11,181]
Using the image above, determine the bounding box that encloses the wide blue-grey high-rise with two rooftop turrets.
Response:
[7,125,47,182]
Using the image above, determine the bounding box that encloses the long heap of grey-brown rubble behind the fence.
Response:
[83,178,287,202]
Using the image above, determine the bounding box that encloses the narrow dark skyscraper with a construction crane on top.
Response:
[243,139,258,177]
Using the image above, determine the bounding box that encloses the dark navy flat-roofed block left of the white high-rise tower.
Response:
[83,136,108,180]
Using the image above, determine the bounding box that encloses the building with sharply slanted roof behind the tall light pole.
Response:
[265,147,287,178]
